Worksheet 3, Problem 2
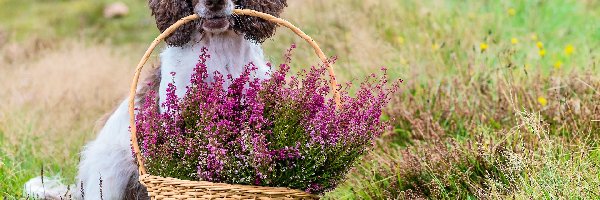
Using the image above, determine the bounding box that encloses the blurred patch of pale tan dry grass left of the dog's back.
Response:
[0,41,149,171]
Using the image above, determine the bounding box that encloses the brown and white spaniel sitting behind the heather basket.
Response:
[25,0,287,200]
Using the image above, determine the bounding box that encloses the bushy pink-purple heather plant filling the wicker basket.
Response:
[136,46,397,194]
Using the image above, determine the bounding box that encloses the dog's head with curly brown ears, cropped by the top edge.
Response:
[148,0,287,46]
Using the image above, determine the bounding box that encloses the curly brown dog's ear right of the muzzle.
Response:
[233,0,287,43]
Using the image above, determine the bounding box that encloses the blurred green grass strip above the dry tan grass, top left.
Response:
[0,0,158,44]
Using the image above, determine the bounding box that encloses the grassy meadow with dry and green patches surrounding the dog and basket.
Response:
[0,0,600,199]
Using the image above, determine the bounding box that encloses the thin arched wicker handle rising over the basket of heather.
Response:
[129,9,341,175]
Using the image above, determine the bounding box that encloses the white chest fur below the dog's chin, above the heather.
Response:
[159,31,270,103]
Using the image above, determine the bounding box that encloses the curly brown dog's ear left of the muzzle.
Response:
[148,0,197,46]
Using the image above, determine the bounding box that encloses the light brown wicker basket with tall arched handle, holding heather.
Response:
[129,9,340,199]
